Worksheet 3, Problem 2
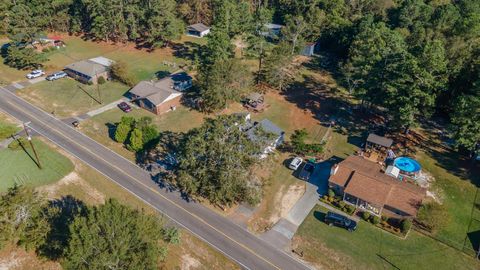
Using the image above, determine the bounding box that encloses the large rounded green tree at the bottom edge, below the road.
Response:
[63,200,166,269]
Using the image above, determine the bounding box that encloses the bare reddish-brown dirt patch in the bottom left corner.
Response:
[0,247,62,270]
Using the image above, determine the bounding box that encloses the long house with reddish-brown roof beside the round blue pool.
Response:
[328,156,426,218]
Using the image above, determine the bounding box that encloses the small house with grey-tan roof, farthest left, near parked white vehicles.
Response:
[64,57,114,84]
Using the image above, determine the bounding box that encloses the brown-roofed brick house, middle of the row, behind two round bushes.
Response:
[129,72,192,114]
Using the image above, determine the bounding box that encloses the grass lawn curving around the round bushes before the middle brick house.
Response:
[80,106,204,161]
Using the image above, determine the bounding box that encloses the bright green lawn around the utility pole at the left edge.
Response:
[0,139,73,192]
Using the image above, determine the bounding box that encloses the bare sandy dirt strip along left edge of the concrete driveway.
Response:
[269,184,305,224]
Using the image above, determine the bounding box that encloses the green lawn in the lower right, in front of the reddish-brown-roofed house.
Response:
[294,206,480,270]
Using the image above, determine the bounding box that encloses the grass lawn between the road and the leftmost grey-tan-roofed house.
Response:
[17,78,128,117]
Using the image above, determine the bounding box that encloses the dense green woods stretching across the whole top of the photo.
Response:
[0,0,480,149]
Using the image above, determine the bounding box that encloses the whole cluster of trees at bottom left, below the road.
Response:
[0,186,180,269]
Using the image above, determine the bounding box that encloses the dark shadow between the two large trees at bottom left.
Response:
[38,195,86,260]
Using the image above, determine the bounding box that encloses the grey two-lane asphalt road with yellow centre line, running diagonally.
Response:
[0,88,309,270]
